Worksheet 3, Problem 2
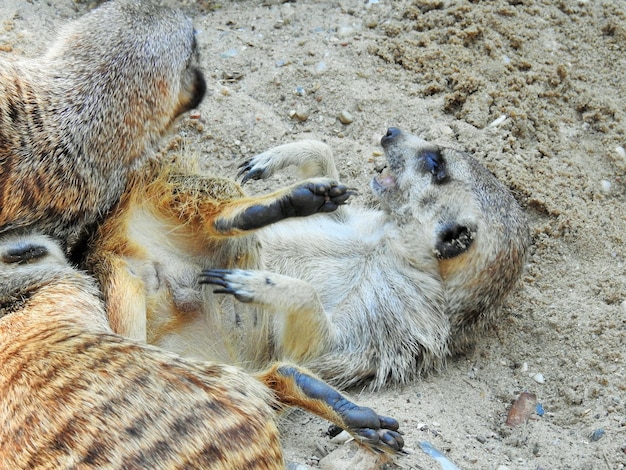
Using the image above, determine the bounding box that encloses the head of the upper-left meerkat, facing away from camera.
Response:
[44,0,206,161]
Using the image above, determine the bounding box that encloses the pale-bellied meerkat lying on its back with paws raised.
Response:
[88,129,529,388]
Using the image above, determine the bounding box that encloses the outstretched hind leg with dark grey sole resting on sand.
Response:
[257,364,404,452]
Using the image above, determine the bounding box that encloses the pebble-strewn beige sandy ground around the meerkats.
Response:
[0,0,626,470]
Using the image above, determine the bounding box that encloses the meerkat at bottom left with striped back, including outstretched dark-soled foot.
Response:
[0,235,402,470]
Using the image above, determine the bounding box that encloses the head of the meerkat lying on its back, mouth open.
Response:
[371,128,528,332]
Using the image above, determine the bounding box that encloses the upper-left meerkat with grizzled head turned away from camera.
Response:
[0,0,206,258]
